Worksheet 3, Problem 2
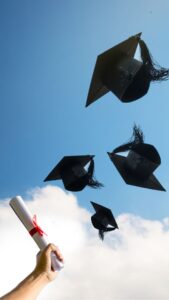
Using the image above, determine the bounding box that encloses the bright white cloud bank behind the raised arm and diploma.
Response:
[0,186,169,300]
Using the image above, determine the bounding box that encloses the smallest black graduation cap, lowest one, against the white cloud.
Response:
[90,201,118,240]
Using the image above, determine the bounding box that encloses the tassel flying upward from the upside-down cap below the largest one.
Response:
[113,125,144,153]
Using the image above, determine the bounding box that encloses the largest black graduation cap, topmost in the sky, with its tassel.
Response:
[86,33,169,106]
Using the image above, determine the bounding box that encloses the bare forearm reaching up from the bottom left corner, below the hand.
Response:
[0,271,48,300]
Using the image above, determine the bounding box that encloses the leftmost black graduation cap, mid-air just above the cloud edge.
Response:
[44,155,103,192]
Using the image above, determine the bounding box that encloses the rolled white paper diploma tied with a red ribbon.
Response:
[9,196,63,271]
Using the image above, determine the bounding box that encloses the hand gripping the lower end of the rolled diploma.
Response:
[34,244,63,282]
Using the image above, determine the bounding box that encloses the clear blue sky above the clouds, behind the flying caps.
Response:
[0,0,169,219]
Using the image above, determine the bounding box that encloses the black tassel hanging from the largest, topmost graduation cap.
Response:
[139,40,169,81]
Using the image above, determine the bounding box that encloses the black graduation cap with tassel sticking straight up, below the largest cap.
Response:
[108,126,165,191]
